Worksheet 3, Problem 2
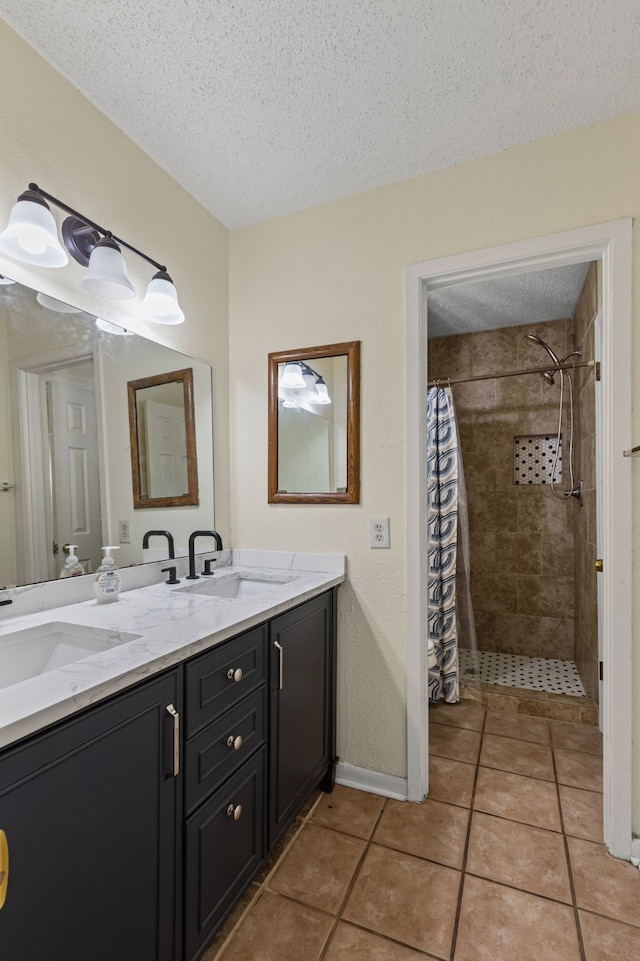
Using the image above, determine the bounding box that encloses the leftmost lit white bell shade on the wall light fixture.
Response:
[0,190,69,267]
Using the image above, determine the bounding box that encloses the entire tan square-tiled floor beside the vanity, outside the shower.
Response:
[201,703,640,961]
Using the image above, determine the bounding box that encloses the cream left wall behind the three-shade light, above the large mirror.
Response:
[0,21,230,543]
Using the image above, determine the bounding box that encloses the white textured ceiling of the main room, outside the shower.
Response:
[0,0,640,227]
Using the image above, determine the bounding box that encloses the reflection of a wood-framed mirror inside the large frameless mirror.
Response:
[127,367,199,509]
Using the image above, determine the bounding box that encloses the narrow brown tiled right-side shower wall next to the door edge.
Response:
[574,264,598,701]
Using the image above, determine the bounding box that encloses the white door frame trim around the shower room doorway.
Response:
[405,218,632,858]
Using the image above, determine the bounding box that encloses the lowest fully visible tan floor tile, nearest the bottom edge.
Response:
[343,844,460,958]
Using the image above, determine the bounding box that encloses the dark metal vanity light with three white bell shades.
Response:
[0,184,184,324]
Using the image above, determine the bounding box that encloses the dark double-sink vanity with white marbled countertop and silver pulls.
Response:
[0,552,343,961]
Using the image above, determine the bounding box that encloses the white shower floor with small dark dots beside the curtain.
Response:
[459,650,586,697]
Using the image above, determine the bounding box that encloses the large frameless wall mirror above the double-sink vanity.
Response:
[0,283,215,588]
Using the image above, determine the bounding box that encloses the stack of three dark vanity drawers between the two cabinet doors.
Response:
[184,625,267,961]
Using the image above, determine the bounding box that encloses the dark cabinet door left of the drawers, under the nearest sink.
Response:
[0,671,180,961]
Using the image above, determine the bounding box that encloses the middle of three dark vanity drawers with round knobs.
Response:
[185,685,267,815]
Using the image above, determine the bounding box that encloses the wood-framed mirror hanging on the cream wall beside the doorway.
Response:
[269,341,360,504]
